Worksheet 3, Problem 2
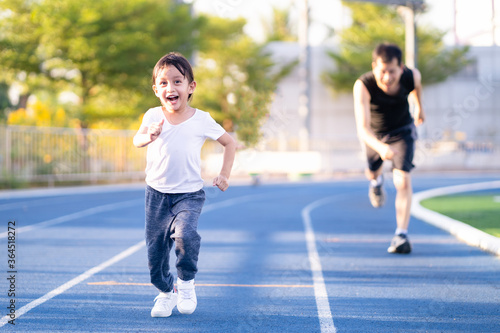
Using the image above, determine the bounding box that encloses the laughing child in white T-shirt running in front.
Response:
[134,52,236,317]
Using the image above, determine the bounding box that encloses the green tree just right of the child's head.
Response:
[192,17,296,146]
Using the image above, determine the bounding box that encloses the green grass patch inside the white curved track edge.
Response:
[421,192,500,237]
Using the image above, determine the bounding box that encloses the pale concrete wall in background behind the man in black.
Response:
[259,43,500,172]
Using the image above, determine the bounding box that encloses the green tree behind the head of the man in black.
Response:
[322,2,470,92]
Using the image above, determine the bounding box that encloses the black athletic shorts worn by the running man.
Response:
[365,123,417,172]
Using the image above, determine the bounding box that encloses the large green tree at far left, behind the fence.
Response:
[0,0,202,127]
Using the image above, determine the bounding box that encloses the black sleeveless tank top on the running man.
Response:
[359,66,415,134]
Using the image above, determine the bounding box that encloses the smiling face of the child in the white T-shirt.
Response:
[153,66,196,112]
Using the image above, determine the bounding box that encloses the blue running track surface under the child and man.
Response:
[0,174,500,333]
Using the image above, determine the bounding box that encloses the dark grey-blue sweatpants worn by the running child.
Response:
[145,186,205,292]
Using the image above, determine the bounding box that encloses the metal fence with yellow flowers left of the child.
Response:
[0,126,146,184]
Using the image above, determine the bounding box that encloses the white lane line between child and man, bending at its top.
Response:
[302,196,339,333]
